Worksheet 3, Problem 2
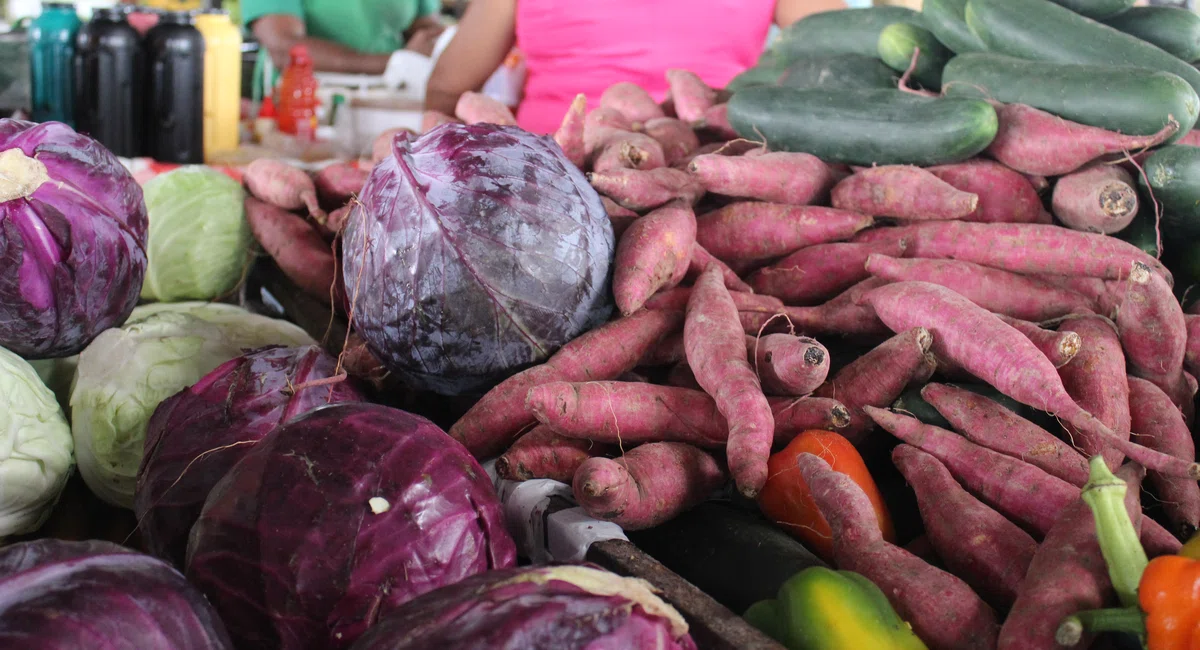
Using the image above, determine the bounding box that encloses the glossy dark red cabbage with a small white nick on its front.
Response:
[186,403,516,650]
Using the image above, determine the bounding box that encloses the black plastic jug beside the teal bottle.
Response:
[73,8,145,157]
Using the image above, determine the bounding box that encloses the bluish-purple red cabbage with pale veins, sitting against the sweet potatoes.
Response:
[342,124,613,395]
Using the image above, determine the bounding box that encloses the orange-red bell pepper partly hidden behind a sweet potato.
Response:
[758,429,895,560]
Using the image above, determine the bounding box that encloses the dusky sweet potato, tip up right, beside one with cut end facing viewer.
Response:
[816,327,935,445]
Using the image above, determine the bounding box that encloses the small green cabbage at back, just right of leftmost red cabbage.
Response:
[142,165,251,302]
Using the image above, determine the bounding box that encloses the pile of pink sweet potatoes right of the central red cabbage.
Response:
[430,71,1200,649]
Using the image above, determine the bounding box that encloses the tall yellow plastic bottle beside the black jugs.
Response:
[196,11,241,161]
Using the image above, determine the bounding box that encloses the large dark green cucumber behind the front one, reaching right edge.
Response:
[942,53,1200,139]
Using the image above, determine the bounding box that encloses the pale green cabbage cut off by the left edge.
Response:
[0,348,74,537]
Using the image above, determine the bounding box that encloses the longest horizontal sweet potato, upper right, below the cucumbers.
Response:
[854,221,1171,279]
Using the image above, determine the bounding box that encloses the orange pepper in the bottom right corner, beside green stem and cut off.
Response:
[1138,555,1200,650]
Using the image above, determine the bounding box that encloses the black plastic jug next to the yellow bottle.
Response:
[143,12,204,164]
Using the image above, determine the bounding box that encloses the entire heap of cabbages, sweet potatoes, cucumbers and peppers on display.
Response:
[0,0,1200,650]
